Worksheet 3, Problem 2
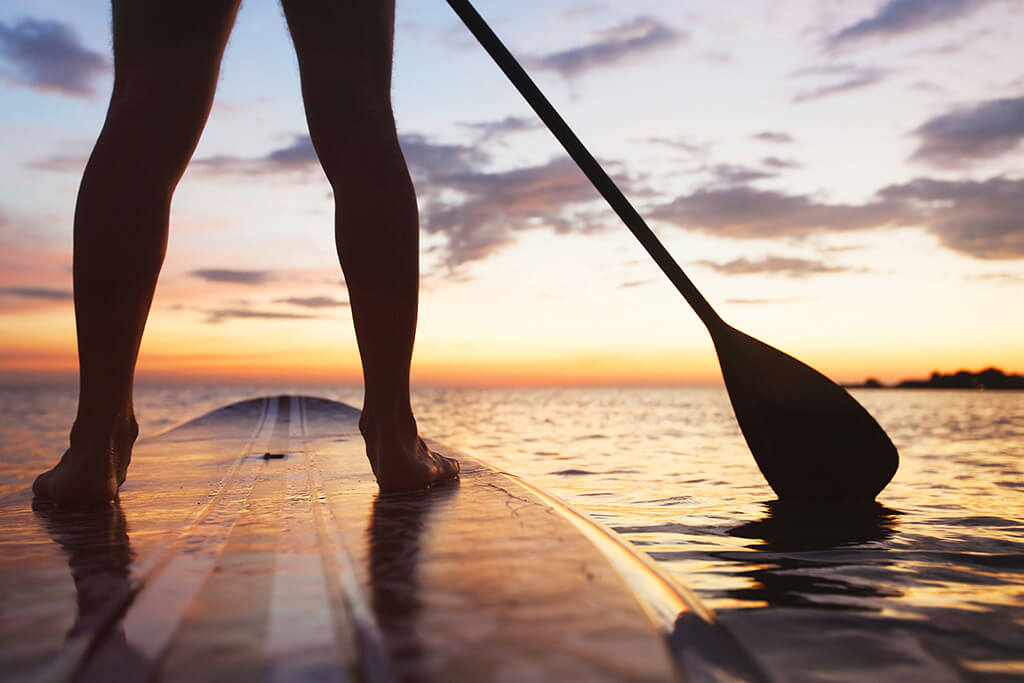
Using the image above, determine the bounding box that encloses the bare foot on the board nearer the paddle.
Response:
[359,413,459,493]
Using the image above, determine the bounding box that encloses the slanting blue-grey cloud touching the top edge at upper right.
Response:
[827,0,990,47]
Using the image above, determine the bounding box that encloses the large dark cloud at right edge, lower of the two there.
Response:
[878,176,1024,259]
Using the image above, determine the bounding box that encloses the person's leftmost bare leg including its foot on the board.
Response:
[33,0,239,506]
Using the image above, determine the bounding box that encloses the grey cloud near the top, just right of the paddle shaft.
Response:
[532,16,687,78]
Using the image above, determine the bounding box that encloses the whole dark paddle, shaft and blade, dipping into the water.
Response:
[447,0,899,501]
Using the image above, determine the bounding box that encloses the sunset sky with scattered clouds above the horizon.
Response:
[0,0,1024,385]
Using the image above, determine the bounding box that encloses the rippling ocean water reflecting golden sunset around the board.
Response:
[0,386,1024,682]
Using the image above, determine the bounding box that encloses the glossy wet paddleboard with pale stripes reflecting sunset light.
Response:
[0,396,764,681]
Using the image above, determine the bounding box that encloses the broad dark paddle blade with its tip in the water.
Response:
[712,325,899,501]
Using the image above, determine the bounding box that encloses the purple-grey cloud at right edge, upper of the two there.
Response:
[911,97,1024,167]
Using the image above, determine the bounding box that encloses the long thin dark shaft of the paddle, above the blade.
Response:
[447,0,722,331]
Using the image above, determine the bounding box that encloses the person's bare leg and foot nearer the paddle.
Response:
[282,0,459,490]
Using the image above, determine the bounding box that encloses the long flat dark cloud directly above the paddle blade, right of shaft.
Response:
[650,185,916,239]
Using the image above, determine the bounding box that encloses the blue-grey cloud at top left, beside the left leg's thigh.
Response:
[0,18,110,97]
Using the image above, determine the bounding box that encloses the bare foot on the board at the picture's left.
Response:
[32,418,138,508]
